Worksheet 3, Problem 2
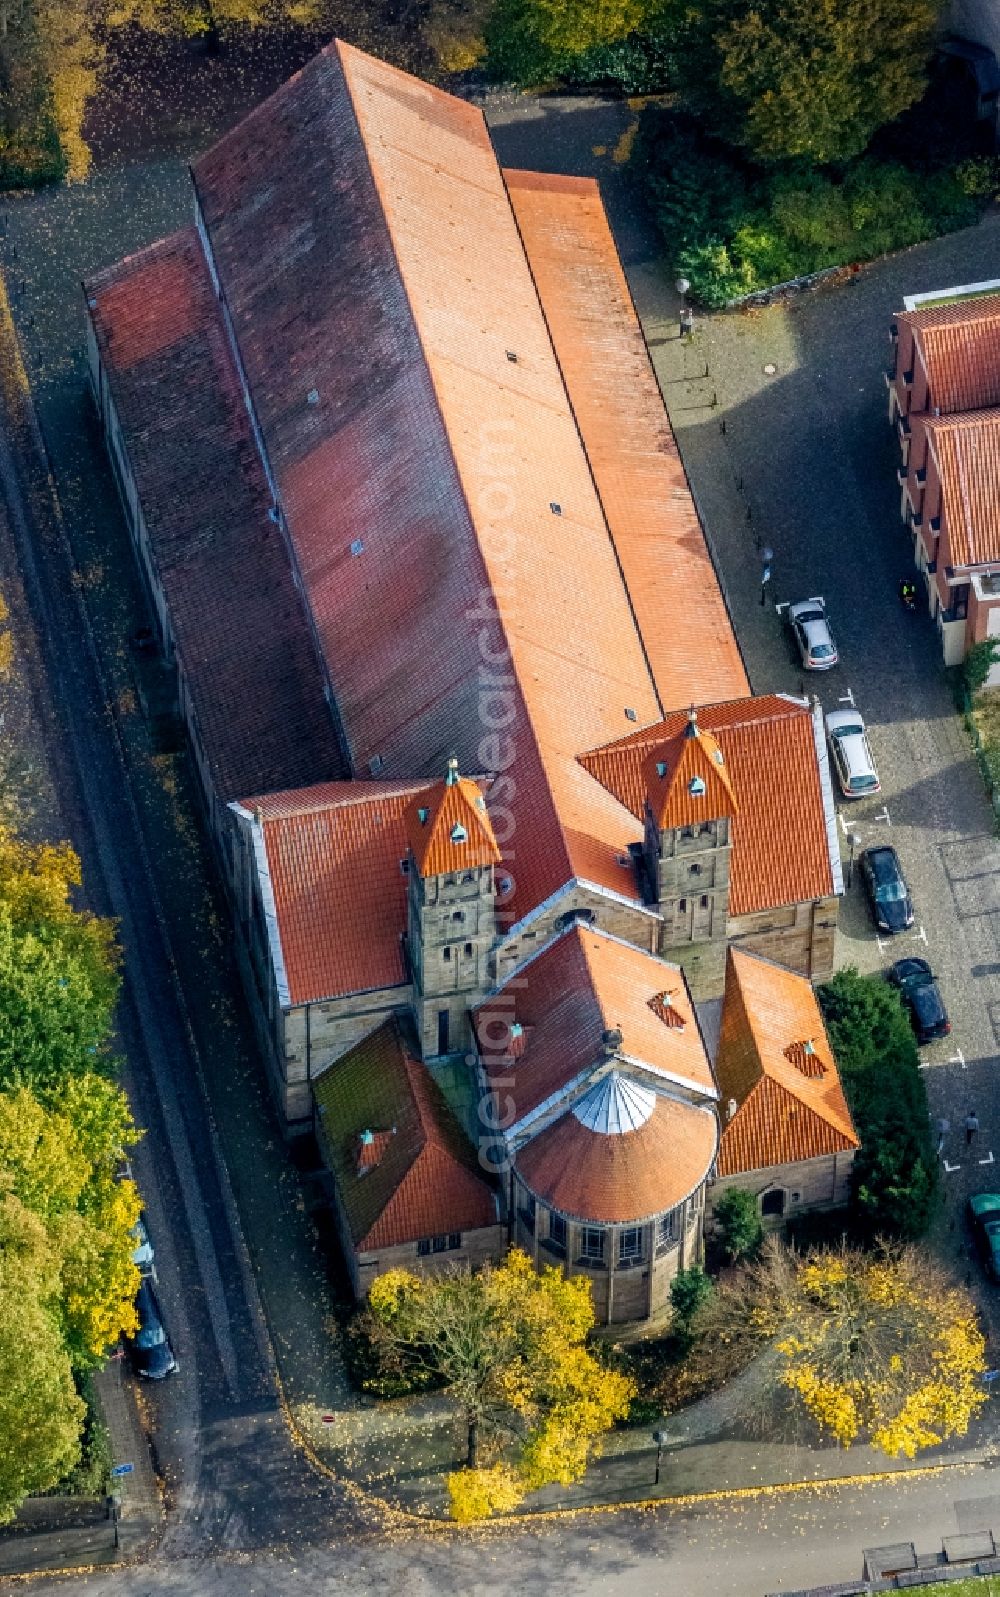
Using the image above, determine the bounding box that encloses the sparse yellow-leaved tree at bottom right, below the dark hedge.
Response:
[706,1241,986,1458]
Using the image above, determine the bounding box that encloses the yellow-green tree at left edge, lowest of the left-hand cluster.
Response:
[0,1193,85,1522]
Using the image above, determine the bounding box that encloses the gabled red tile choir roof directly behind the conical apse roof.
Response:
[474,925,716,1121]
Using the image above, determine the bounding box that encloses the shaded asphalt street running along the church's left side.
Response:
[0,236,371,1557]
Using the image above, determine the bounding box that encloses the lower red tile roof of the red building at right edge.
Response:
[914,410,1000,565]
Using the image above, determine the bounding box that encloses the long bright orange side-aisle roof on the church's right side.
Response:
[503,171,751,709]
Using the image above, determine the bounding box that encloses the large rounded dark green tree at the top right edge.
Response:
[684,0,941,164]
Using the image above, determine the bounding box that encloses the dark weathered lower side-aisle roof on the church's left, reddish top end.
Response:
[86,228,343,800]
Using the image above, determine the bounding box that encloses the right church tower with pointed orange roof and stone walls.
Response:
[642,709,736,998]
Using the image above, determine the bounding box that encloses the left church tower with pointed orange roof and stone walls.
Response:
[406,759,500,1059]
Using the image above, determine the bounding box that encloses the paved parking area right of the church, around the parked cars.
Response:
[610,217,1000,1309]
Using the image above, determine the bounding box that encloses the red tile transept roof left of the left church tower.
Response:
[243,781,427,1005]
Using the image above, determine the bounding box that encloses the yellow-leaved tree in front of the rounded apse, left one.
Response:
[369,1249,636,1522]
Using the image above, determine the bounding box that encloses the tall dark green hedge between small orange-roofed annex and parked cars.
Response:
[819,966,938,1238]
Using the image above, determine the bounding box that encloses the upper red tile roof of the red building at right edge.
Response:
[896,294,1000,415]
